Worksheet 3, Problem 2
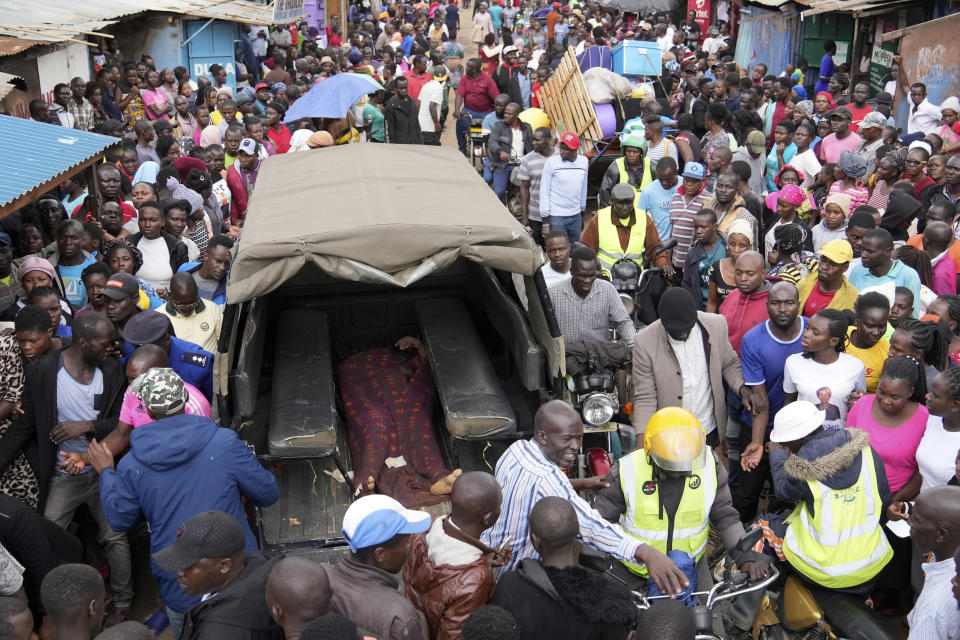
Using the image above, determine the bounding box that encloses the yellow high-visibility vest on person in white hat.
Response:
[783,446,893,589]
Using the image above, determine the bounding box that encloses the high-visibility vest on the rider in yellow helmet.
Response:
[620,449,717,578]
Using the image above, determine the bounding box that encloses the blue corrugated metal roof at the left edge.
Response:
[0,116,120,207]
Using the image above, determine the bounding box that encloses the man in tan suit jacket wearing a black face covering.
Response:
[633,287,757,446]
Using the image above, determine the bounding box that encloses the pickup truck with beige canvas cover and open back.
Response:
[215,144,564,559]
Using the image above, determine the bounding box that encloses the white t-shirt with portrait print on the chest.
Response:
[783,353,867,429]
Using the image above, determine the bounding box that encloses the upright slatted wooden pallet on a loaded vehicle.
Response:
[537,47,603,153]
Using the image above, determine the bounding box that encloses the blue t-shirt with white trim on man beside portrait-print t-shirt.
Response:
[740,316,807,433]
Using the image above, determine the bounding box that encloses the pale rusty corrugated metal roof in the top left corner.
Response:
[0,0,273,46]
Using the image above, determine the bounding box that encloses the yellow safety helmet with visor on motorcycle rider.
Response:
[643,407,707,473]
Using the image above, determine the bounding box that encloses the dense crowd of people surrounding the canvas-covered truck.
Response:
[0,0,960,640]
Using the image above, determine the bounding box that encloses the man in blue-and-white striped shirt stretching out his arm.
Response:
[481,400,689,593]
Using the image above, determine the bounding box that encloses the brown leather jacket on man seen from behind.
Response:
[403,519,494,640]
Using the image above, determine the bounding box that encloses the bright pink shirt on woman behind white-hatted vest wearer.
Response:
[847,394,930,493]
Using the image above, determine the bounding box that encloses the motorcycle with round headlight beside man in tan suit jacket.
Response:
[567,341,637,478]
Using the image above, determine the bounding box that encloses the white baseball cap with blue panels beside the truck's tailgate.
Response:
[342,494,431,551]
